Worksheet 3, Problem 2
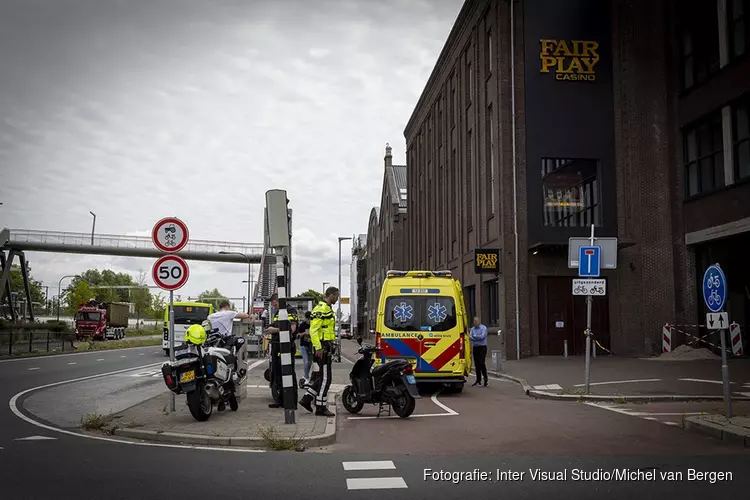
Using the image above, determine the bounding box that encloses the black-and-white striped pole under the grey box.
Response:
[276,252,297,424]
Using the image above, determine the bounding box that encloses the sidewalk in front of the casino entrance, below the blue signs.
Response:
[488,355,750,400]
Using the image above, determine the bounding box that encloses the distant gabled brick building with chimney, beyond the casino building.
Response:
[366,145,406,331]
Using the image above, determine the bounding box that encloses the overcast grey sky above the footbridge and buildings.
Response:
[0,0,463,312]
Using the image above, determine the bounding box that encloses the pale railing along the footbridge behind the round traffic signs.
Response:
[5,229,263,256]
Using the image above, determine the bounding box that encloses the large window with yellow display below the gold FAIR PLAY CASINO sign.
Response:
[542,158,602,227]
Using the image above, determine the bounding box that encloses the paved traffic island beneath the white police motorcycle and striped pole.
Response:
[105,386,336,450]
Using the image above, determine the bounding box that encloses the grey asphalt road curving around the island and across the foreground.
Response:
[0,347,750,500]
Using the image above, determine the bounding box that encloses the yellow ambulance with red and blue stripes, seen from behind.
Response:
[375,271,471,392]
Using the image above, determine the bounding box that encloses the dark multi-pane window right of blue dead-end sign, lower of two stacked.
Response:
[682,111,724,197]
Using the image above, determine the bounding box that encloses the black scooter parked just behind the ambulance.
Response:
[341,337,421,418]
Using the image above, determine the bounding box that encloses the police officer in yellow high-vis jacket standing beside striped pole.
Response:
[299,286,339,417]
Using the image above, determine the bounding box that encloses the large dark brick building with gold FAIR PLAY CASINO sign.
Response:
[402,0,750,359]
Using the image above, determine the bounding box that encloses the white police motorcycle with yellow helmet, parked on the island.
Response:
[161,321,248,422]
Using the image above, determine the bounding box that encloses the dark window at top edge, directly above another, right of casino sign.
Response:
[679,0,721,90]
